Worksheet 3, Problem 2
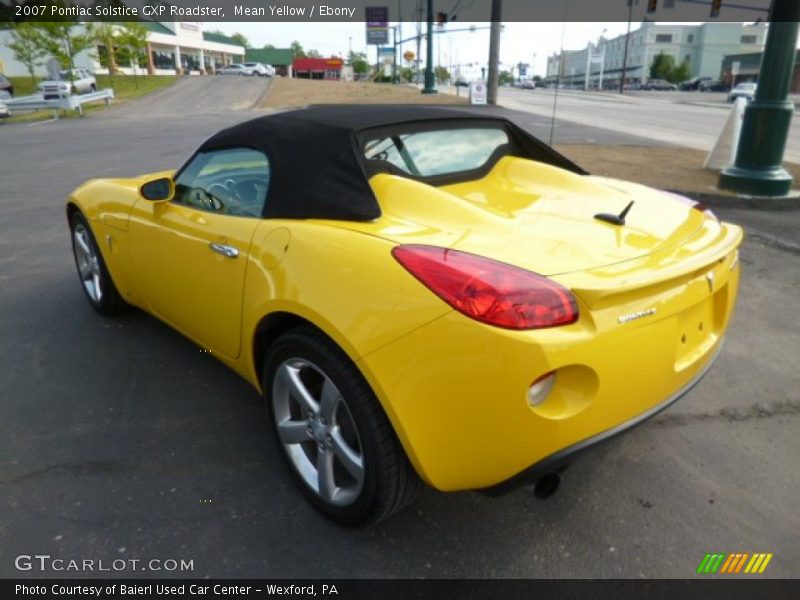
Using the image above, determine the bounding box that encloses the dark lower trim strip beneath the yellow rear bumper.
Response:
[480,339,724,496]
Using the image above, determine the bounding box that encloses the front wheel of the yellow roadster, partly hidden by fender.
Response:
[69,212,130,316]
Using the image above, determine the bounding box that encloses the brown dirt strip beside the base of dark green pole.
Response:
[556,144,800,195]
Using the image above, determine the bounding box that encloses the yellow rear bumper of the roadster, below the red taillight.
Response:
[357,239,739,491]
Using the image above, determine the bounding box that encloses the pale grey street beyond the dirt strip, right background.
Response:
[500,88,800,163]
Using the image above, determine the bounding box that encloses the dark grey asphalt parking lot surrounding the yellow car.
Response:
[0,78,800,578]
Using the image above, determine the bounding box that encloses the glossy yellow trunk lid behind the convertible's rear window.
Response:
[356,157,706,276]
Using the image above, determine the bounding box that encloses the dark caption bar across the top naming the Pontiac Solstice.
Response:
[0,0,797,23]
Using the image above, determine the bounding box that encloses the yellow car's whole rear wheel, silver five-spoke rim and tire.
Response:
[263,326,421,525]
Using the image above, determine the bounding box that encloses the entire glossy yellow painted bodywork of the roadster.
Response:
[69,157,742,490]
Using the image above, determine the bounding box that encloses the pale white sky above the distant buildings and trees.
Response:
[212,22,638,76]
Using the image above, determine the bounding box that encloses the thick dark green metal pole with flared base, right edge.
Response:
[719,0,800,196]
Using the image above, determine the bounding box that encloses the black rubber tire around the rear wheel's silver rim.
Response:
[263,326,422,526]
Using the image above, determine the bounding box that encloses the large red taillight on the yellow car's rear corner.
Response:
[392,245,578,329]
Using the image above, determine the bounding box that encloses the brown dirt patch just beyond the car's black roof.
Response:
[261,77,467,108]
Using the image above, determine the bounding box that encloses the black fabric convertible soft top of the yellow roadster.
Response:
[198,105,584,221]
